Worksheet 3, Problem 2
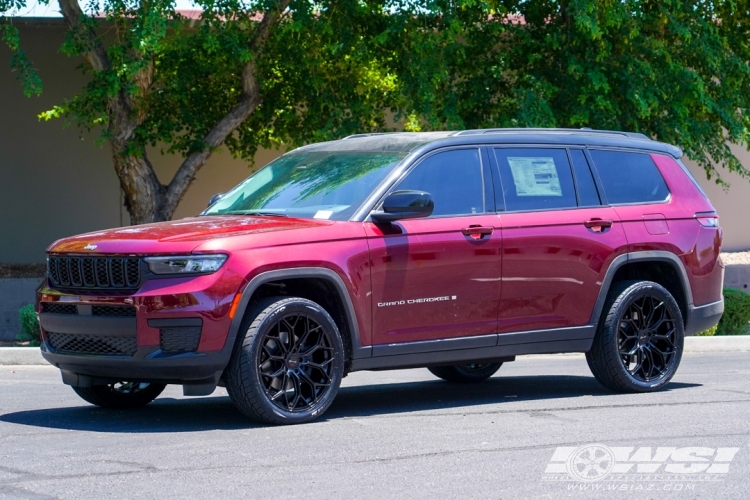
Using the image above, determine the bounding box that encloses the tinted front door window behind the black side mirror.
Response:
[396,149,484,216]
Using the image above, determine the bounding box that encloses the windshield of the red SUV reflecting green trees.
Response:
[203,150,407,220]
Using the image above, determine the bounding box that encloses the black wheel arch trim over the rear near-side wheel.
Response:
[589,250,693,330]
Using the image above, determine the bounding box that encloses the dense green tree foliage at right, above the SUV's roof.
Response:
[383,0,750,183]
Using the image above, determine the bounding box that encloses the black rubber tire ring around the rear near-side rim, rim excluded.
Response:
[601,281,685,392]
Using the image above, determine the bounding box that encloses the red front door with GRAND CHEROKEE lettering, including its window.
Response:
[365,148,502,344]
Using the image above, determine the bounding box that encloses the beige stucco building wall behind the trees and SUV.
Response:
[0,19,750,263]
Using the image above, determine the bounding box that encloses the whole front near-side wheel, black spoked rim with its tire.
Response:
[225,297,344,425]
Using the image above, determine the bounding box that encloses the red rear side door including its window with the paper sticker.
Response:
[494,147,626,332]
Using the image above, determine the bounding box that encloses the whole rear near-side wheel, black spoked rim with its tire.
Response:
[586,281,685,392]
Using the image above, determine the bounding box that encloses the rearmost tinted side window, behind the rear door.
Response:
[590,150,669,204]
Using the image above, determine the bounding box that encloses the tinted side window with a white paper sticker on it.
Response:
[495,148,577,211]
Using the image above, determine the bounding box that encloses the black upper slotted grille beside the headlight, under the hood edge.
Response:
[47,255,142,290]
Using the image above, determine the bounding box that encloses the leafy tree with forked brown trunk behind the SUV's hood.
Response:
[0,0,391,224]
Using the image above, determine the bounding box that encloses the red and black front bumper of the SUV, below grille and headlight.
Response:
[38,270,244,395]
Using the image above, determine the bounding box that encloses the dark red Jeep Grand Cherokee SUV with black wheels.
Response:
[38,129,724,424]
